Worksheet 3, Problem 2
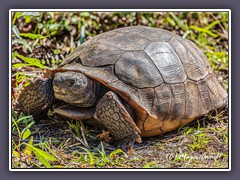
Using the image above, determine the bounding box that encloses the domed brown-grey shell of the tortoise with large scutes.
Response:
[57,26,227,137]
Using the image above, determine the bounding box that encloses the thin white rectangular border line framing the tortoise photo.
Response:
[9,9,232,171]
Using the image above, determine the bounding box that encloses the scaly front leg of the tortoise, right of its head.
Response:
[95,91,142,150]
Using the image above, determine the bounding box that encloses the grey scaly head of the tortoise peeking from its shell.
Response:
[53,71,99,107]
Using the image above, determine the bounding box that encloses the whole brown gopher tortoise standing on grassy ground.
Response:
[19,26,228,147]
